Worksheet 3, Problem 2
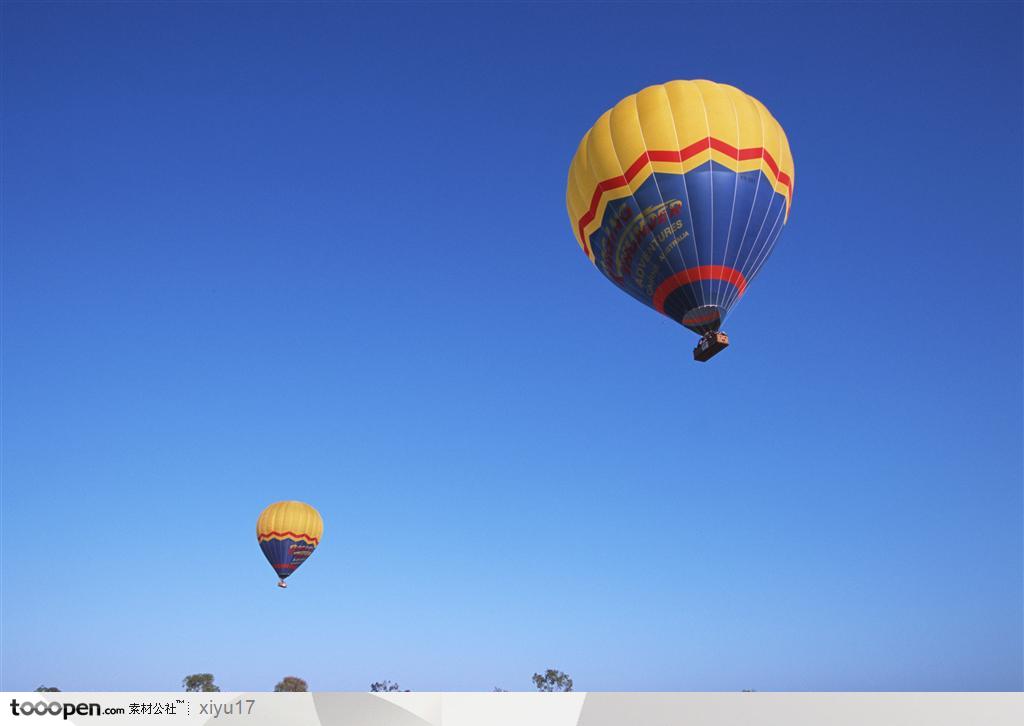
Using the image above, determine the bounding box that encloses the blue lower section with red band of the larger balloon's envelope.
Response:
[589,162,786,333]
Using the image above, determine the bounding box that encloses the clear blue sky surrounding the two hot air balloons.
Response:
[0,3,1024,690]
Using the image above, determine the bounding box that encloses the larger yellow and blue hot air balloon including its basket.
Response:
[565,81,794,360]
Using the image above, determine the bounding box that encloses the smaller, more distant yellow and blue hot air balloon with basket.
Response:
[256,502,324,588]
